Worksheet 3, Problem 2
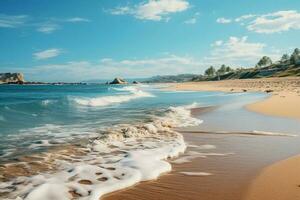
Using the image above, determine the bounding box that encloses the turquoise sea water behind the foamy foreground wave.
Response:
[0,85,266,160]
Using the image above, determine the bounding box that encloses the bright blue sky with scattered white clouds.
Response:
[0,0,300,82]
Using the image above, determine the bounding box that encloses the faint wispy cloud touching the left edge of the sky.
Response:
[0,14,28,28]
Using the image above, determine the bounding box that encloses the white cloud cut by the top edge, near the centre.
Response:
[111,0,190,21]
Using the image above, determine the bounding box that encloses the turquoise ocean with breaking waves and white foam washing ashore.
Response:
[0,84,296,200]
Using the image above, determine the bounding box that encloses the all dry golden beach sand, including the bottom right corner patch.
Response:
[171,78,300,200]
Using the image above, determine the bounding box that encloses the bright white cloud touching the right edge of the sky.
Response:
[247,10,300,34]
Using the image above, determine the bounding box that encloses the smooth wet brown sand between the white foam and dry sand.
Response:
[103,131,299,200]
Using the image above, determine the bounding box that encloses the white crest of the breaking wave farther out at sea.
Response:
[73,87,154,107]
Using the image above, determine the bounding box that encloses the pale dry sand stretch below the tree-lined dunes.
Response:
[170,77,300,120]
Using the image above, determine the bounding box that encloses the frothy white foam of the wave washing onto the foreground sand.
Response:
[0,102,201,200]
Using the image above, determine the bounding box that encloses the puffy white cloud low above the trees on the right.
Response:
[204,36,280,66]
